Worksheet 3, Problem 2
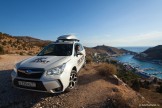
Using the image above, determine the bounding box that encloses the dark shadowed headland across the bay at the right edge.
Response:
[134,45,162,60]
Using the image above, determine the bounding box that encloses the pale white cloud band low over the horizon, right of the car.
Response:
[83,32,162,46]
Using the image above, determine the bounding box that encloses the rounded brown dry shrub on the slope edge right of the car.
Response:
[96,63,117,77]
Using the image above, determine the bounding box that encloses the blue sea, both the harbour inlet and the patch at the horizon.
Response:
[115,47,162,79]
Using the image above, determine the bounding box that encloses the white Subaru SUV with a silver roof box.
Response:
[11,35,86,93]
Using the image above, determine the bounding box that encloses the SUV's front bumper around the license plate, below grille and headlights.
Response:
[12,77,63,93]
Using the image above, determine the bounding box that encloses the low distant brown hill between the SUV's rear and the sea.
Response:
[85,45,136,55]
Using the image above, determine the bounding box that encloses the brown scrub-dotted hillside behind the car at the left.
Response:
[0,32,51,55]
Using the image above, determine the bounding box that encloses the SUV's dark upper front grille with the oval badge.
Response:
[17,68,44,79]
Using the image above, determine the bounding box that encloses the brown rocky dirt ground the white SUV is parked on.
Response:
[0,55,146,108]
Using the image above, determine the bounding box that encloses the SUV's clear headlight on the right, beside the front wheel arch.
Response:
[46,63,66,76]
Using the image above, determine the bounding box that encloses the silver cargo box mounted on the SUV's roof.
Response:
[57,35,79,42]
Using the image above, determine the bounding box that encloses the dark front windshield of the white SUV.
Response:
[38,44,73,56]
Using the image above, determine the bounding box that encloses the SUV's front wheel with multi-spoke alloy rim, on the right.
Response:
[66,70,78,92]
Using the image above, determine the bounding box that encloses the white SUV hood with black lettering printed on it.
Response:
[18,56,71,70]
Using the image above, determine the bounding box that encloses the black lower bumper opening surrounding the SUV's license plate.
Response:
[13,79,47,91]
